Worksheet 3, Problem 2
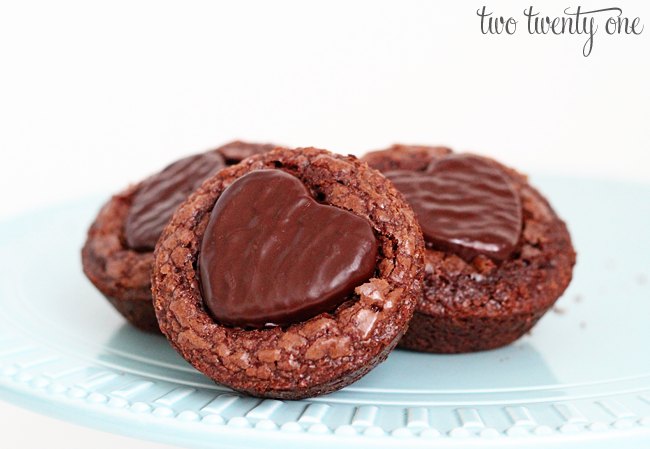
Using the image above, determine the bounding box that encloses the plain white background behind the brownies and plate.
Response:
[0,0,650,448]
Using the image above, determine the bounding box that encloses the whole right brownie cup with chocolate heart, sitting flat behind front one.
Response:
[362,145,576,353]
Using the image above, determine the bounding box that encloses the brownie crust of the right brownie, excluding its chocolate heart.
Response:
[362,145,576,353]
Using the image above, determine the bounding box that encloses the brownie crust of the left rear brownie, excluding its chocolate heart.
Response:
[81,142,274,332]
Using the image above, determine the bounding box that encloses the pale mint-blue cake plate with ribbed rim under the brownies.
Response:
[0,177,650,449]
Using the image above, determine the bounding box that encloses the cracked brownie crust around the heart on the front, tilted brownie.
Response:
[152,148,424,399]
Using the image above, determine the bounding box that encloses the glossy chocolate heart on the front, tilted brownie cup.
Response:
[198,170,378,328]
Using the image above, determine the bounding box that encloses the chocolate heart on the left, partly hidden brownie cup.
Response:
[124,152,226,251]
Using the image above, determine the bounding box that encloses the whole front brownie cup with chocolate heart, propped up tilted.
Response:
[152,148,424,400]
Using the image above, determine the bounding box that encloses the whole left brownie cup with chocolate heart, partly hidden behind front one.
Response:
[81,142,275,332]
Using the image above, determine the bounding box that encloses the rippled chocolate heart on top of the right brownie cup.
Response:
[385,154,522,262]
